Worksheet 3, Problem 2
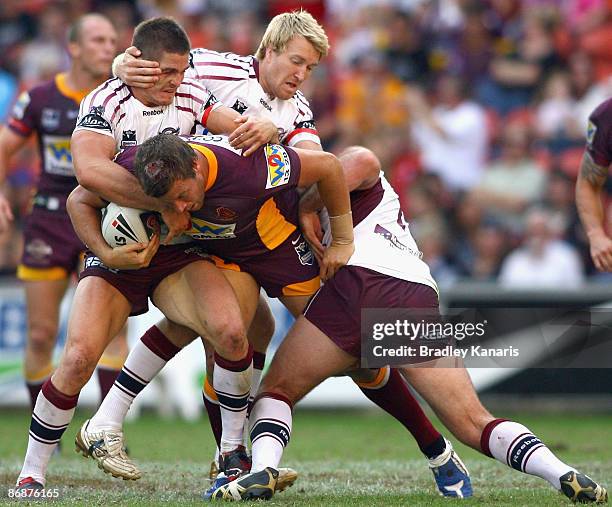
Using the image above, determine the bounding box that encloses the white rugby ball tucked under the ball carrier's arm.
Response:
[102,202,160,248]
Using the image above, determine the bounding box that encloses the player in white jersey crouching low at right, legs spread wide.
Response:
[212,147,607,503]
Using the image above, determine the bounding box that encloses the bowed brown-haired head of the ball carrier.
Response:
[134,134,196,197]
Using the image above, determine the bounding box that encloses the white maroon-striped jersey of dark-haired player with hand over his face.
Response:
[75,78,219,151]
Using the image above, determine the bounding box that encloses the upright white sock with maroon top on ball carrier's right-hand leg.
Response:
[213,349,253,453]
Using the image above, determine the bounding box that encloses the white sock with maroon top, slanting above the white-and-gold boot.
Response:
[89,326,180,432]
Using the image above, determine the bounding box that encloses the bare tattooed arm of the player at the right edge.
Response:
[576,151,612,271]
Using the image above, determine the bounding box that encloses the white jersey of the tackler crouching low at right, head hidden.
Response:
[321,172,438,292]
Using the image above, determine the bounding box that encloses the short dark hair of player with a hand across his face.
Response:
[132,17,191,61]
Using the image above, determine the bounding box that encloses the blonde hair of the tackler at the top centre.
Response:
[256,9,329,60]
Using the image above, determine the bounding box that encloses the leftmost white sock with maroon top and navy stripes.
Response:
[17,379,78,486]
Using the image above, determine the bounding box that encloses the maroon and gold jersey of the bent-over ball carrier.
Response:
[116,135,300,263]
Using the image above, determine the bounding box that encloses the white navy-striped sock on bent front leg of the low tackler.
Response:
[250,396,292,472]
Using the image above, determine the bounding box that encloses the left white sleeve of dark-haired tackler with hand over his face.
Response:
[74,79,125,138]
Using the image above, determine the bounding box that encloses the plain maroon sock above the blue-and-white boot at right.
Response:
[360,369,441,457]
